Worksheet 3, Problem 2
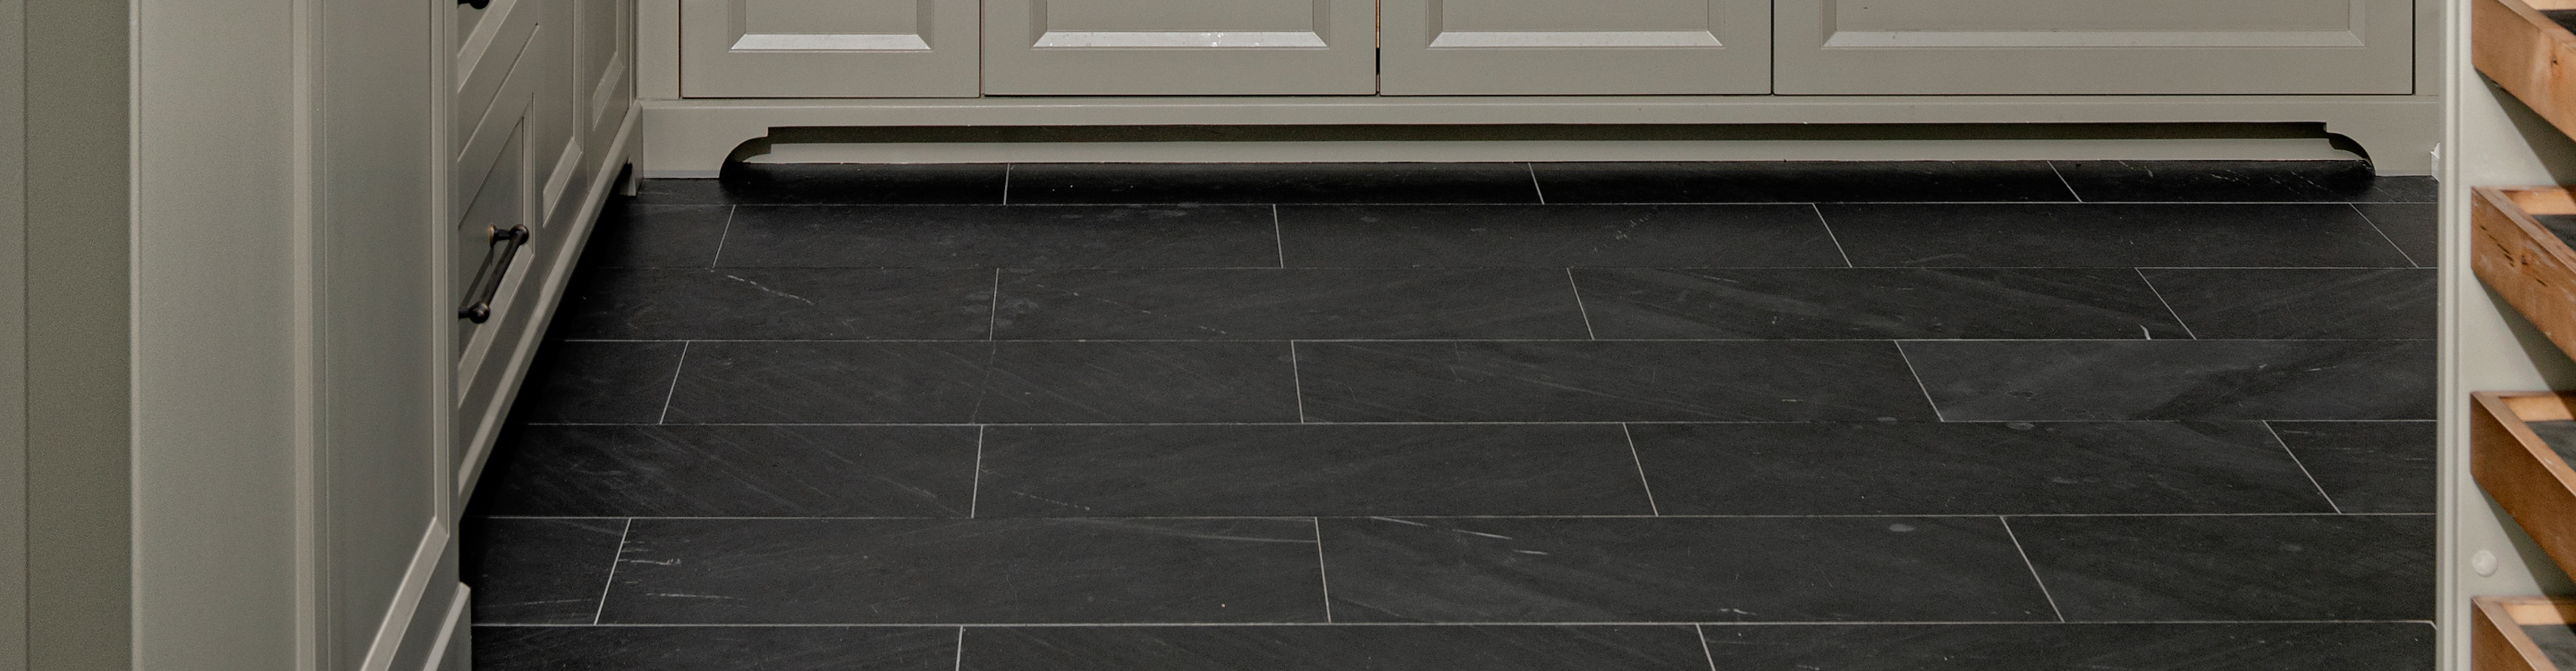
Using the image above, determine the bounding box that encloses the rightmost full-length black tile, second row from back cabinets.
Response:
[1834,203,2411,267]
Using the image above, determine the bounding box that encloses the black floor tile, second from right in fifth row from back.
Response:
[1631,422,2338,514]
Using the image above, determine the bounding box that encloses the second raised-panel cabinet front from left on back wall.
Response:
[984,0,1378,95]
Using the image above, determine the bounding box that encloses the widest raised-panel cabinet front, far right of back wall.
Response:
[1772,0,2413,95]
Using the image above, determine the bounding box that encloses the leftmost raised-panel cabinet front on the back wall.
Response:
[680,0,976,97]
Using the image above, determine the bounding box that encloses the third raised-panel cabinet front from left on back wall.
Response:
[1378,0,1772,95]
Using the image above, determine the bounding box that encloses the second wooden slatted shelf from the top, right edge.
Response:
[2468,188,2576,352]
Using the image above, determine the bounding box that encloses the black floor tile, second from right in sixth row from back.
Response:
[1324,516,2056,622]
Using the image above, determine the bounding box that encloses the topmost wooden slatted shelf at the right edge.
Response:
[2470,0,2576,137]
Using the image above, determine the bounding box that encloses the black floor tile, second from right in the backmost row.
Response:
[1533,162,2073,203]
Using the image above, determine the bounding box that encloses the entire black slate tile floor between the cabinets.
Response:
[464,162,2435,671]
